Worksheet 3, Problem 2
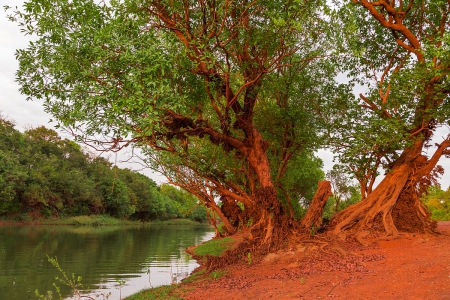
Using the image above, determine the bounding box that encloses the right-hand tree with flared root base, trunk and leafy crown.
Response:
[333,0,450,236]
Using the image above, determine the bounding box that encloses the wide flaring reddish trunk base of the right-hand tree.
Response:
[331,140,437,236]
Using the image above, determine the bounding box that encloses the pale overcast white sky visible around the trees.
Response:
[0,0,450,189]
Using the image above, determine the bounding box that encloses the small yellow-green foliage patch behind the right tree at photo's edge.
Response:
[421,185,450,221]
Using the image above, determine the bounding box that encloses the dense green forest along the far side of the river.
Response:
[0,116,206,222]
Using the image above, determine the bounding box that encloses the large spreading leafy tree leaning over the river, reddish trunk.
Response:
[10,0,337,248]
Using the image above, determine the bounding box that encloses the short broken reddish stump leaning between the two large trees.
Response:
[300,180,333,233]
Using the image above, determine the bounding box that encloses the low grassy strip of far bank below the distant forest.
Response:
[0,215,207,226]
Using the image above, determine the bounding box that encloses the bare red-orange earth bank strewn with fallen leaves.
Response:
[127,222,450,300]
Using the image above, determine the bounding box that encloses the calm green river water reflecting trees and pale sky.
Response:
[0,226,214,300]
